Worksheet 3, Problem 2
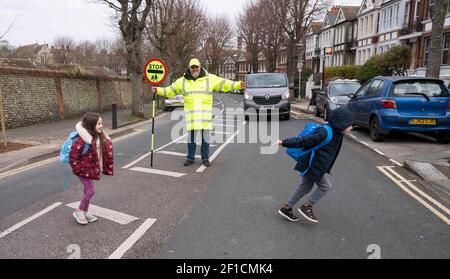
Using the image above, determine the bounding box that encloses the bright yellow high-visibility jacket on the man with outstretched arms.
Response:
[156,69,242,131]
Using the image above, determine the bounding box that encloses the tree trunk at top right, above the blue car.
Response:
[425,0,448,78]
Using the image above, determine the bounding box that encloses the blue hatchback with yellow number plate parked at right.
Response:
[347,77,450,143]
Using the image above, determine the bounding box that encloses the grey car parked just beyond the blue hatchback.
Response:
[315,79,361,120]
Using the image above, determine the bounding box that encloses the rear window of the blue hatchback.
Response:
[391,80,449,97]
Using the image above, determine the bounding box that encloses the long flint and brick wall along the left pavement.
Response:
[0,67,132,128]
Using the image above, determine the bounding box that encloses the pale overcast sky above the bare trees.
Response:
[0,0,361,46]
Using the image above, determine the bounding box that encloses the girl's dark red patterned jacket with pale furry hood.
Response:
[69,122,114,180]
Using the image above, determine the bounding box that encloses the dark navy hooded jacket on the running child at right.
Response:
[282,108,355,182]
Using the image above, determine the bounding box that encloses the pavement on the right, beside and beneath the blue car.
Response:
[292,99,450,199]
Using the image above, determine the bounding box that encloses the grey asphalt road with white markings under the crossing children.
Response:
[0,94,450,259]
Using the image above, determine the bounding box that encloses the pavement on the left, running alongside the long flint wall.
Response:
[0,104,160,174]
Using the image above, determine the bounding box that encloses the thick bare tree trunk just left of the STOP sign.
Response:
[100,0,153,117]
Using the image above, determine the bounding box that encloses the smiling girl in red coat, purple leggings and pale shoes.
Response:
[69,112,113,225]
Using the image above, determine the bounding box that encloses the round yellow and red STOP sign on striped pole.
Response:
[144,58,168,168]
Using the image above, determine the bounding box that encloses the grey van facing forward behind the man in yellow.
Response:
[244,73,291,120]
